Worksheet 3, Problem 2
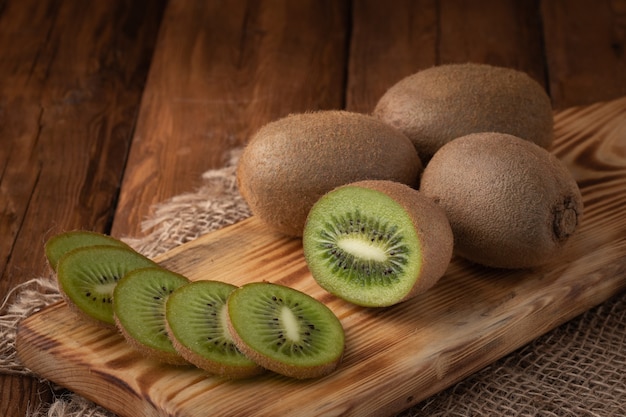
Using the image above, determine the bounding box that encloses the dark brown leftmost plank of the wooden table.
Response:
[0,0,163,416]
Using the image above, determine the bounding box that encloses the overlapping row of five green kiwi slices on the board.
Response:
[45,231,345,379]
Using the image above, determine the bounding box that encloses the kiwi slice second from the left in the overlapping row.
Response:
[57,245,158,327]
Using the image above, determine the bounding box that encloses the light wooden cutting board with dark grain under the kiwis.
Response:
[17,98,626,417]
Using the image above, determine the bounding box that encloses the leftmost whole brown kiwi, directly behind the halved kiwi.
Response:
[237,110,422,236]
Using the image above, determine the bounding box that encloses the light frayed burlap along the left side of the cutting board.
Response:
[0,149,250,417]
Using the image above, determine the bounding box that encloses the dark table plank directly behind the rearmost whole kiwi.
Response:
[346,0,545,112]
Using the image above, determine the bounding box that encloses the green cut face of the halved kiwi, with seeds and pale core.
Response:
[303,186,422,307]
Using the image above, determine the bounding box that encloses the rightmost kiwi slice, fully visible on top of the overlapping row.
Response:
[227,282,345,379]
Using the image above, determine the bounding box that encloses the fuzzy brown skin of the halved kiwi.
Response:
[342,180,454,302]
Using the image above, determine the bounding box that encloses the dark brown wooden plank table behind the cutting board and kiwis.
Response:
[0,0,626,416]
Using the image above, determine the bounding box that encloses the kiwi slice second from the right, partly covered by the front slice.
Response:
[165,280,264,378]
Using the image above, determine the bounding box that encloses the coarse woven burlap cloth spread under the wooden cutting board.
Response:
[0,151,626,417]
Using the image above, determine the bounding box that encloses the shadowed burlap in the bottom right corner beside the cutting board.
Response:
[398,293,626,417]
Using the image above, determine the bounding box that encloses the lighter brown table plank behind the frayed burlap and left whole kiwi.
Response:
[113,0,348,236]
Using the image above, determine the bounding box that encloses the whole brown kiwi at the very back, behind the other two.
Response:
[373,63,553,164]
